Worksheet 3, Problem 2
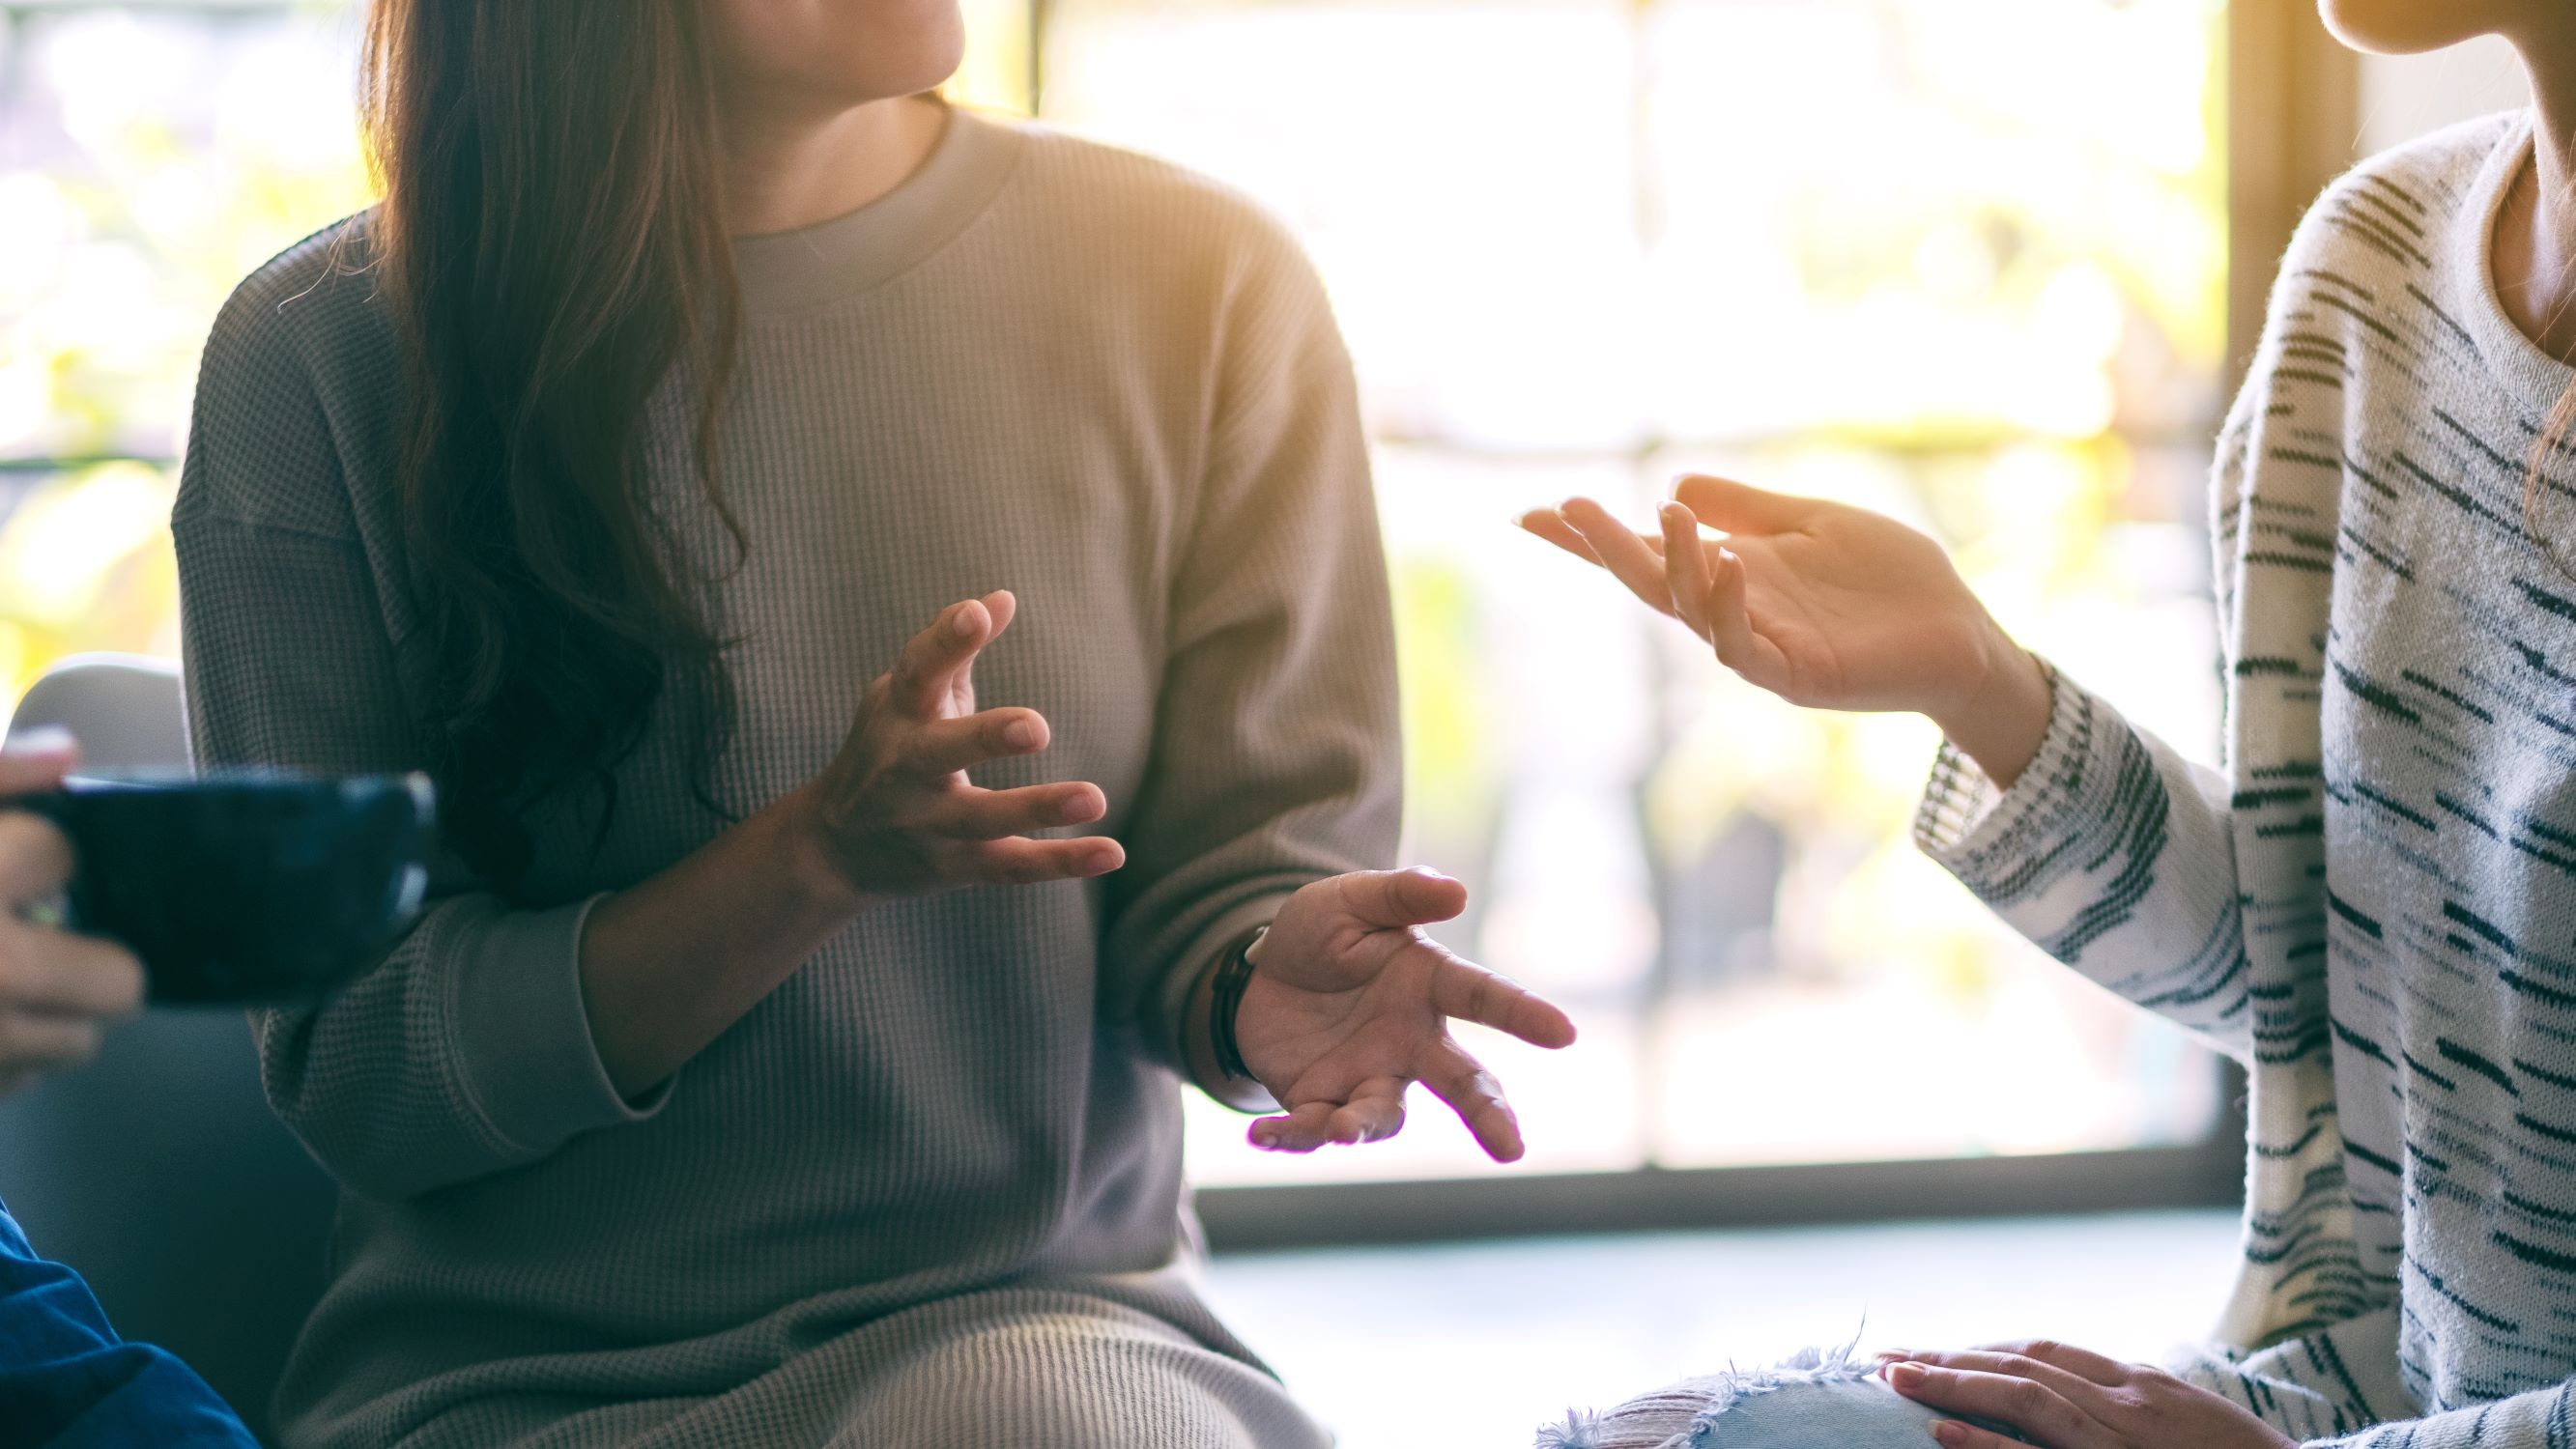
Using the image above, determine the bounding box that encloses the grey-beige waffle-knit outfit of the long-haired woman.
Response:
[175,113,1399,1449]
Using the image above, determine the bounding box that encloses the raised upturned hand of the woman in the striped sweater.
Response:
[1520,476,2050,785]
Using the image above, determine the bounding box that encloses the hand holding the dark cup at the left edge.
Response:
[0,744,144,1096]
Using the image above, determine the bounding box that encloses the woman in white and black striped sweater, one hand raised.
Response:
[1525,0,2576,1449]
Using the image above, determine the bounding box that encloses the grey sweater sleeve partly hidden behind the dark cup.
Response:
[173,278,649,1200]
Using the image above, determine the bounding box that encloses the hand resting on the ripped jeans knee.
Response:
[1880,1341,2295,1449]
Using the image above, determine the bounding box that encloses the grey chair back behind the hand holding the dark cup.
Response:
[0,654,337,1438]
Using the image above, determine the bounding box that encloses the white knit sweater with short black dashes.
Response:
[1917,116,2576,1449]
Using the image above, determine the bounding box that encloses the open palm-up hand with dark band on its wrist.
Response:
[1234,870,1574,1163]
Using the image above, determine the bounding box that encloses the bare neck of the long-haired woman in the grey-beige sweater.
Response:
[724,96,948,237]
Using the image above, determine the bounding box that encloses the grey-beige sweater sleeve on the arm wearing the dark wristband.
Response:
[1102,210,1401,1053]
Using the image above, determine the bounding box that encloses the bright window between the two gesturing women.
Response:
[1044,0,2225,1184]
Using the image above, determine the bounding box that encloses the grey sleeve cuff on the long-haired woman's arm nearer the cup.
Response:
[451,895,673,1158]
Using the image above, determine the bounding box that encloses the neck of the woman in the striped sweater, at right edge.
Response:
[2491,36,2576,363]
